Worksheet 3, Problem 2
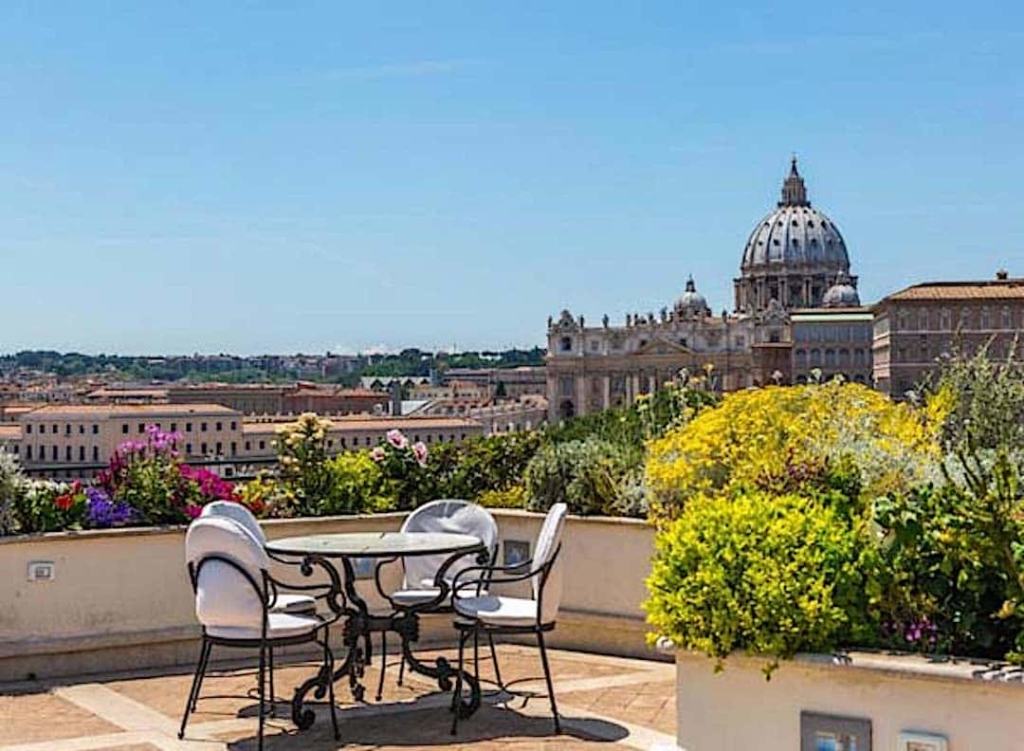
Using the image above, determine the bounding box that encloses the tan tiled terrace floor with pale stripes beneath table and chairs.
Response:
[0,645,675,751]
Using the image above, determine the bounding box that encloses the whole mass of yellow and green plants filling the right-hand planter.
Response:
[646,352,1024,672]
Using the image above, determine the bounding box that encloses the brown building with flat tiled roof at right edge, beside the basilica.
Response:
[872,270,1024,398]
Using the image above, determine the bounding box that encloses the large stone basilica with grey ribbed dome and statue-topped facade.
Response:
[547,158,871,420]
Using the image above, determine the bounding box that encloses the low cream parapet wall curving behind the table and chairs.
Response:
[0,510,656,681]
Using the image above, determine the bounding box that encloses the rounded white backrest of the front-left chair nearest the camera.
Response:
[185,516,269,628]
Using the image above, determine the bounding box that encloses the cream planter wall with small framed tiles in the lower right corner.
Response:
[676,653,1024,751]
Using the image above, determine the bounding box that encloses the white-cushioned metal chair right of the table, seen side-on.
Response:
[452,503,568,734]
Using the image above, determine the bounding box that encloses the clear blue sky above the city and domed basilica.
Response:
[0,0,1024,353]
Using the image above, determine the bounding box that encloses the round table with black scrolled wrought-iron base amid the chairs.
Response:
[266,532,487,729]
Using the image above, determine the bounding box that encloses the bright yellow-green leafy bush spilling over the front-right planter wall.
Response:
[645,492,876,667]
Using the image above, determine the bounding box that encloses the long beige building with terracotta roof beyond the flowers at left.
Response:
[0,404,484,479]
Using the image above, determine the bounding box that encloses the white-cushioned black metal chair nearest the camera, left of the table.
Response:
[178,514,339,749]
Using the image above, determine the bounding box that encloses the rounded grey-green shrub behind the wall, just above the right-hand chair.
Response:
[523,437,634,514]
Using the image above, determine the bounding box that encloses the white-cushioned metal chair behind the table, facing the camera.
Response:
[376,498,502,701]
